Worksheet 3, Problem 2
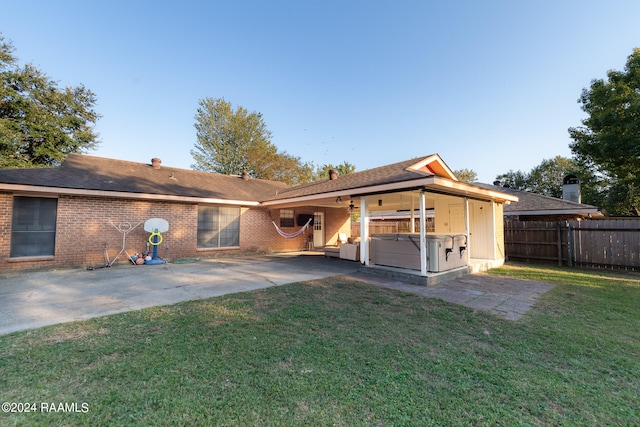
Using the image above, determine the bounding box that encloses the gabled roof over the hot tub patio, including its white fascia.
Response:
[262,154,517,205]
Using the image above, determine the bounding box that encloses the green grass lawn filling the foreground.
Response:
[0,265,640,426]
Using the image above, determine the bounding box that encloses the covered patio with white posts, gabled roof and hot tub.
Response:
[262,154,518,283]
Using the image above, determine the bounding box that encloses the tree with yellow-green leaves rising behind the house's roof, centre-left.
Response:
[191,98,313,185]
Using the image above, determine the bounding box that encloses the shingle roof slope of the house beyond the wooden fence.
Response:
[473,182,599,214]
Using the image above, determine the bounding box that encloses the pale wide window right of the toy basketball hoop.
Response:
[198,205,240,249]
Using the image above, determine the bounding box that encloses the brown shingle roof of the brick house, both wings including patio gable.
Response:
[0,154,520,207]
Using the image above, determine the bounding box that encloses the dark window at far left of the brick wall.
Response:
[9,196,58,258]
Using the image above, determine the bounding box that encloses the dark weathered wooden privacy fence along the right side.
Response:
[504,219,640,270]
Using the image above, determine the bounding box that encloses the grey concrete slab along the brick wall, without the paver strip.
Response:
[0,253,360,335]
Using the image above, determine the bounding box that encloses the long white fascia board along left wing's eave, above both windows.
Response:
[0,184,260,206]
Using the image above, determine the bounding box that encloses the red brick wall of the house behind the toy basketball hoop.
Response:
[0,193,349,269]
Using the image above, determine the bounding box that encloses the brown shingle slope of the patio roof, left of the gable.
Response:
[261,157,433,201]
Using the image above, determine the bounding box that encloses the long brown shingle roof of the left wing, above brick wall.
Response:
[0,154,289,204]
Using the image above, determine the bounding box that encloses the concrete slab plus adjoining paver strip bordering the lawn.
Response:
[0,252,553,335]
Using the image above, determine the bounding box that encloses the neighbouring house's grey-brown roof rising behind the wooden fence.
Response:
[474,182,604,217]
